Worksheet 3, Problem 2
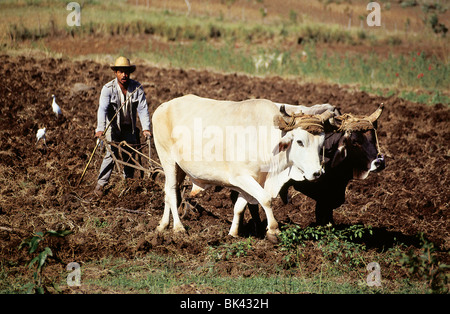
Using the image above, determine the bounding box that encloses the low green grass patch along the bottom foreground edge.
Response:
[4,253,424,294]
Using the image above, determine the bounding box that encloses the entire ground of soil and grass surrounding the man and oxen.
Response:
[0,0,450,293]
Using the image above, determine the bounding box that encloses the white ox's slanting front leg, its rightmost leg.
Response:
[230,176,280,242]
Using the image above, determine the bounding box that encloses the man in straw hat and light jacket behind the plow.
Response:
[94,57,151,197]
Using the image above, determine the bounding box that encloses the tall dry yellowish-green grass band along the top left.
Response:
[0,0,386,44]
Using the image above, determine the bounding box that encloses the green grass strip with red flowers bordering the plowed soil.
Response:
[137,41,450,105]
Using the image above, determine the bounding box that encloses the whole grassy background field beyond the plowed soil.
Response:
[0,0,450,104]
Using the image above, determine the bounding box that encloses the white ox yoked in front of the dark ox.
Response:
[152,95,330,240]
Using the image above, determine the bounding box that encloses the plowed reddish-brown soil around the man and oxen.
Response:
[0,55,450,288]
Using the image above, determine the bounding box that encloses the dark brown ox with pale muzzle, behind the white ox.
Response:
[239,104,386,233]
